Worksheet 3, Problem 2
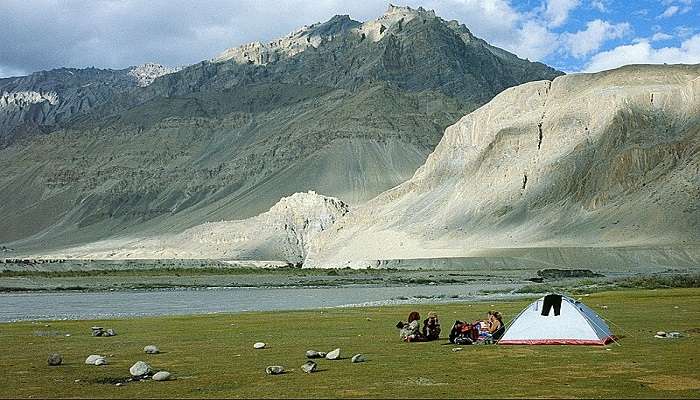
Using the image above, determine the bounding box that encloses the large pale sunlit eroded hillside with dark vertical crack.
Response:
[305,65,700,267]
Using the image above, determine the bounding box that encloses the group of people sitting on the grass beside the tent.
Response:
[396,311,506,345]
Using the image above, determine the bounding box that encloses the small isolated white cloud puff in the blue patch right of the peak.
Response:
[564,19,632,58]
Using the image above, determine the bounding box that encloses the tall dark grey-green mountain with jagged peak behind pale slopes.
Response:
[0,6,561,251]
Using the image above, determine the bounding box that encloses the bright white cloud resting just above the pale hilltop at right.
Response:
[584,34,700,72]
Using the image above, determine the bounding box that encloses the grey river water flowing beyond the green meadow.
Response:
[0,284,516,322]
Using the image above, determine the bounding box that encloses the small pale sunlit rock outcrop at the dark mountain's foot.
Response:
[42,192,350,264]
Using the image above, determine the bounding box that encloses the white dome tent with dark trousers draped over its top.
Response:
[498,294,614,345]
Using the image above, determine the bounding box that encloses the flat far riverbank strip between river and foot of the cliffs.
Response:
[0,259,698,294]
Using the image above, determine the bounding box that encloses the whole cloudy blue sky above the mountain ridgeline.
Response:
[0,0,700,77]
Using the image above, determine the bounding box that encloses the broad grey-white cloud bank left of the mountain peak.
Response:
[0,0,387,75]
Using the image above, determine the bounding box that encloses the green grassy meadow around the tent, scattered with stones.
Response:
[0,288,700,398]
